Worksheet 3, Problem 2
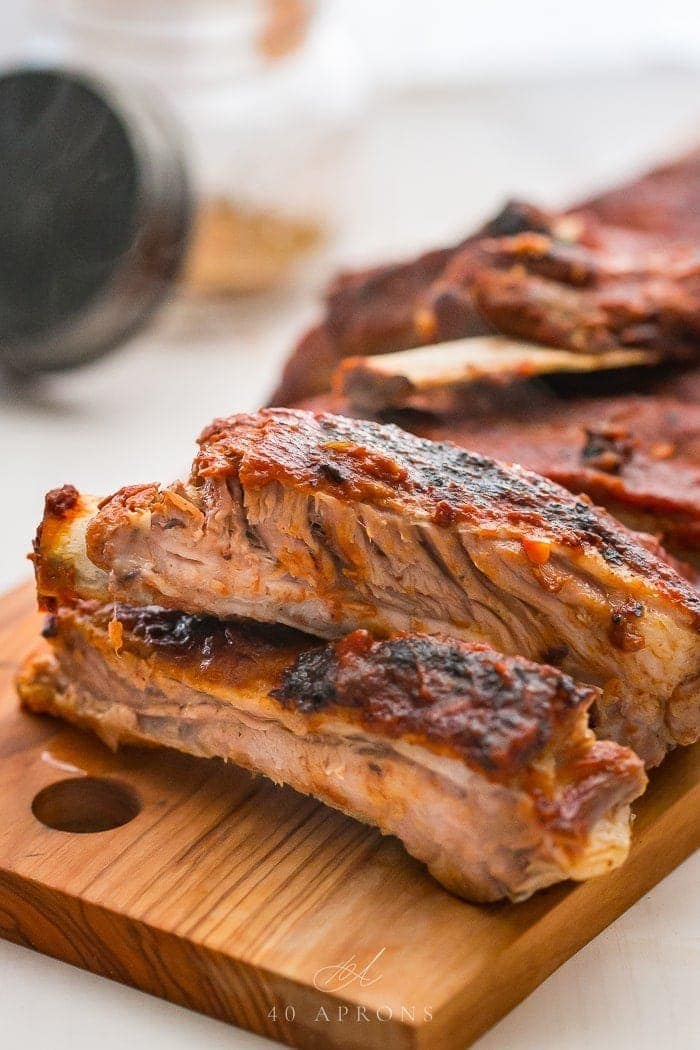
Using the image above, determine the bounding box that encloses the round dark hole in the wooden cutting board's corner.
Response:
[31,777,141,835]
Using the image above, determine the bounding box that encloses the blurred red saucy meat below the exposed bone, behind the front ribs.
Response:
[421,392,700,558]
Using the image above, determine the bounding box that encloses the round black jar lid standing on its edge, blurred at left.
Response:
[0,69,192,375]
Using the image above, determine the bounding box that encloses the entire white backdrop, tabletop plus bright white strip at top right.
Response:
[0,0,700,1050]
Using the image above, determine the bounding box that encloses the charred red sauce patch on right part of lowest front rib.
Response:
[273,631,597,778]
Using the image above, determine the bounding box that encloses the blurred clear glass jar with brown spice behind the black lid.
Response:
[37,0,365,294]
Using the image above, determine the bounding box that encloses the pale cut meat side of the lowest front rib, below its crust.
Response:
[18,630,644,902]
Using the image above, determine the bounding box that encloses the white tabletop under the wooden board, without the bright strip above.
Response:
[0,69,700,1050]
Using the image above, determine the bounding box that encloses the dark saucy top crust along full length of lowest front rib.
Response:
[44,602,617,782]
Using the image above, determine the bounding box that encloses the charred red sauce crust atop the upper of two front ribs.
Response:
[189,408,700,626]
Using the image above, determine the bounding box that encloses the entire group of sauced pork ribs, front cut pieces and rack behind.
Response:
[18,154,700,901]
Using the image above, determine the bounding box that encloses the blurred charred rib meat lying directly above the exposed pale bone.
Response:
[416,202,700,360]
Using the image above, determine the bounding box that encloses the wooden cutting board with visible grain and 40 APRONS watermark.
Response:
[0,587,700,1050]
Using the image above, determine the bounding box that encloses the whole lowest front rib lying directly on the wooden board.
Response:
[19,604,645,901]
